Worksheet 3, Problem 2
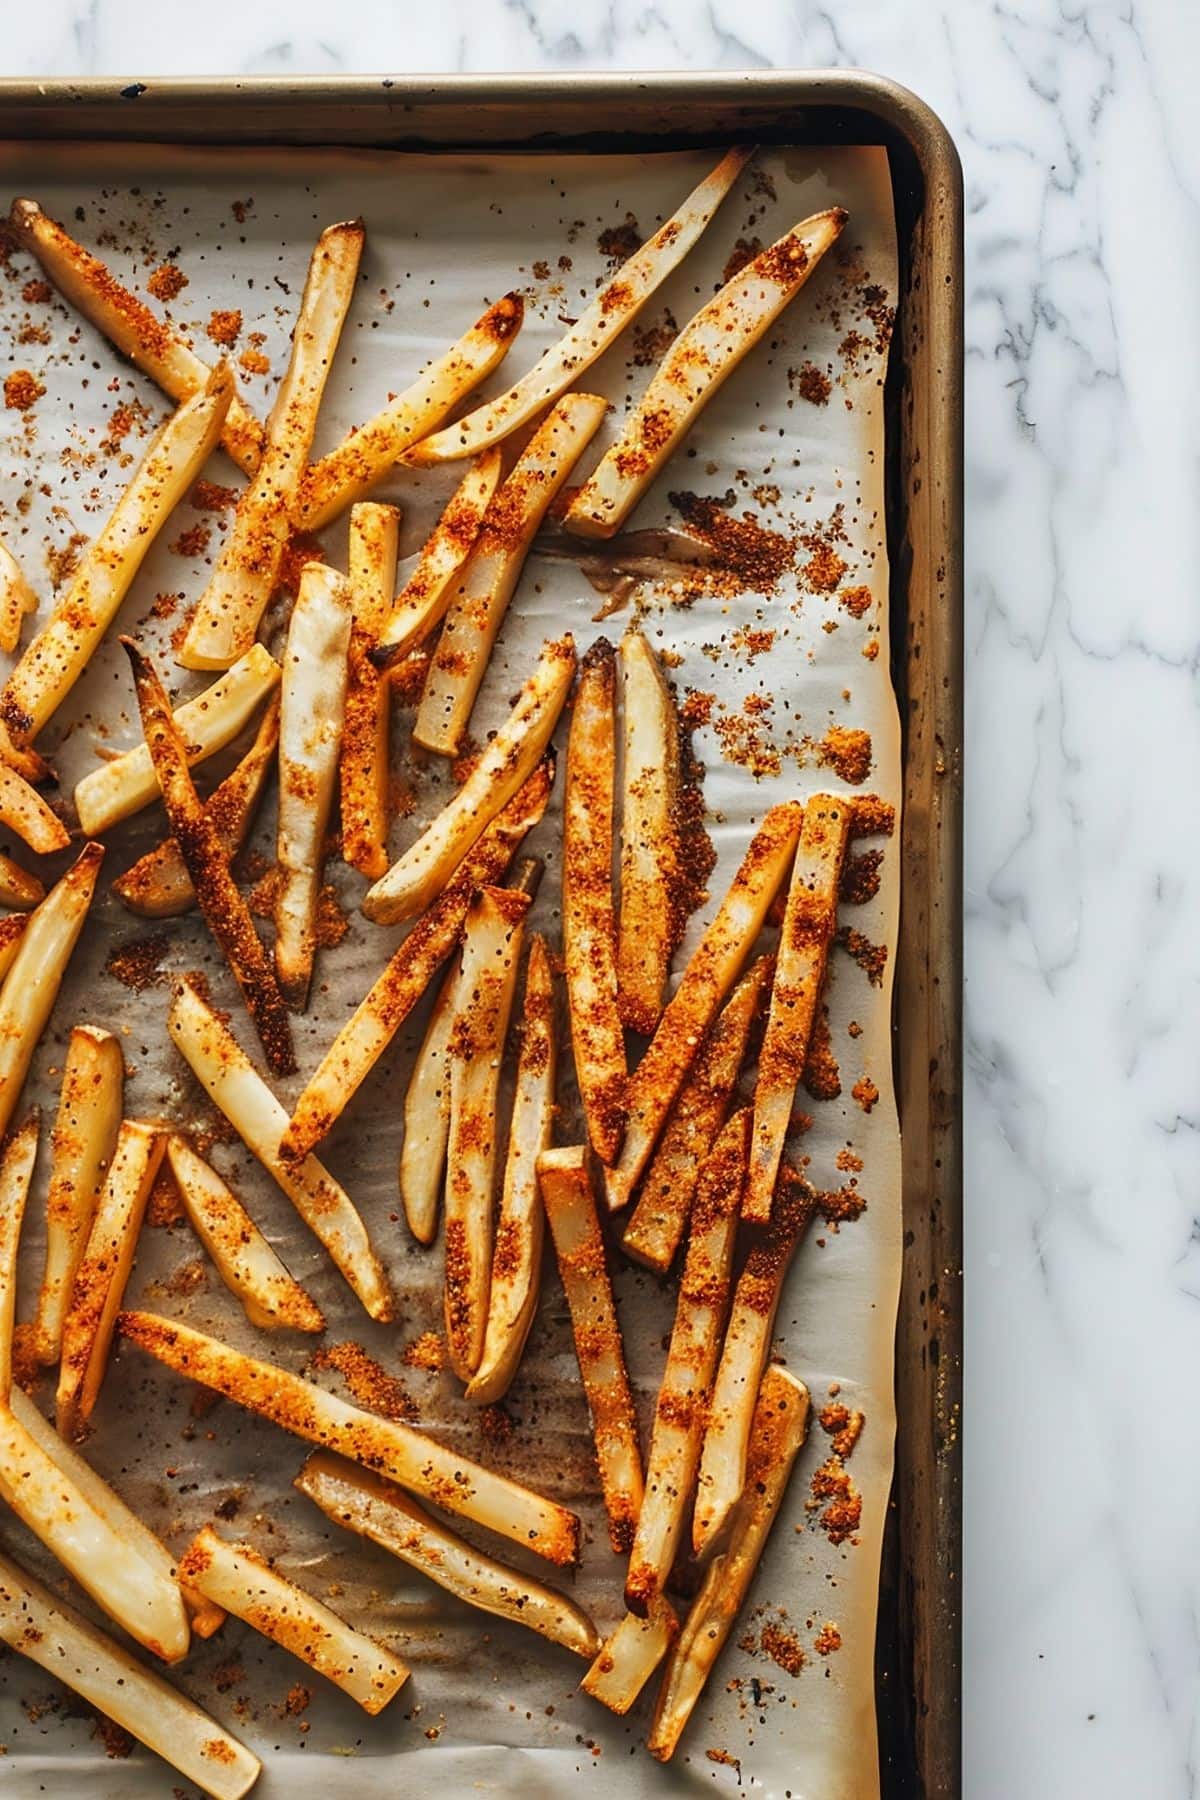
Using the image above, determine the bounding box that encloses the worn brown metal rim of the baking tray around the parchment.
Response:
[0,70,963,1800]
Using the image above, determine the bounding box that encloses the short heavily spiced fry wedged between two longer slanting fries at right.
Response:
[621,956,775,1274]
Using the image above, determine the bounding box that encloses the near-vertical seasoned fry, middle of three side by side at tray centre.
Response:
[443,887,529,1381]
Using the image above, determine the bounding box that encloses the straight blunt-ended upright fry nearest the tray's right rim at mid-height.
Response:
[743,794,855,1224]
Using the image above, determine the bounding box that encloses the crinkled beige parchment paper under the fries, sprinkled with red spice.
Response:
[0,146,900,1800]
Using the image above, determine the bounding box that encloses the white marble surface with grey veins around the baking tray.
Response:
[0,0,1200,1800]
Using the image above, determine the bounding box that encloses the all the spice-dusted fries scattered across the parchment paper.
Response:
[0,148,892,1800]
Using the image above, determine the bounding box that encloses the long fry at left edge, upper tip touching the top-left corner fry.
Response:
[0,369,232,745]
